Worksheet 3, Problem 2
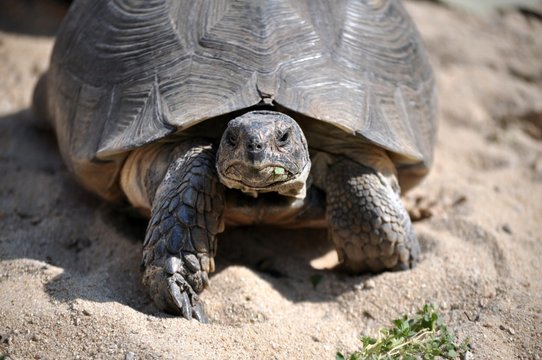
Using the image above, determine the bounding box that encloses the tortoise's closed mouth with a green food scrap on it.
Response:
[222,162,296,190]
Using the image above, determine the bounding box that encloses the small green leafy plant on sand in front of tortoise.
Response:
[336,304,468,360]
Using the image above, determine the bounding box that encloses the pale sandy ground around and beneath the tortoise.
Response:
[0,2,542,359]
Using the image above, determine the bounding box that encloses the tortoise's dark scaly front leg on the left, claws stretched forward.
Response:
[142,143,224,322]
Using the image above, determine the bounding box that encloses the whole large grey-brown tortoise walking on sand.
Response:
[34,0,437,322]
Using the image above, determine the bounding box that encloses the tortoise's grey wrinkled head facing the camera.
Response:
[216,111,311,198]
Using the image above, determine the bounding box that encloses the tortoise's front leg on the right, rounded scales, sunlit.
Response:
[326,159,419,273]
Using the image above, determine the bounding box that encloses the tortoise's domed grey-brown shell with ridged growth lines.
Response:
[46,0,436,198]
